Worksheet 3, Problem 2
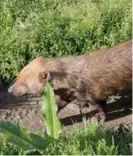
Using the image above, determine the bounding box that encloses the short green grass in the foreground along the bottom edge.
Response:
[0,123,132,155]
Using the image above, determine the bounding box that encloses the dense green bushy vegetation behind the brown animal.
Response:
[0,0,132,80]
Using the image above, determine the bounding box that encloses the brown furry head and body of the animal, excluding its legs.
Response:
[9,40,132,114]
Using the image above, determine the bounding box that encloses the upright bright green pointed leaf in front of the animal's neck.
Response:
[41,83,61,139]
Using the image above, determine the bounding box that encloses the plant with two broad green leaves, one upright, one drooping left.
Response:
[0,84,61,153]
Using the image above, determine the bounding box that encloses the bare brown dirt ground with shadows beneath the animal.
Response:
[0,90,132,132]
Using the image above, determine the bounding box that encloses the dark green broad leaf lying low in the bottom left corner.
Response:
[0,121,49,152]
